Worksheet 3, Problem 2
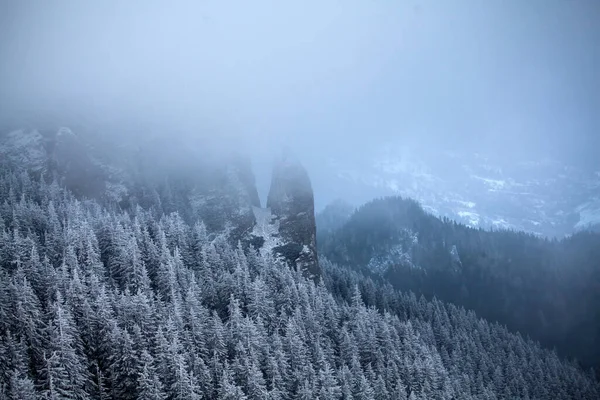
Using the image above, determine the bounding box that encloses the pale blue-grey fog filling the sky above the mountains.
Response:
[0,0,600,206]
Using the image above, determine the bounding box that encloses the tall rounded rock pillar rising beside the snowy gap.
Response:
[267,155,320,278]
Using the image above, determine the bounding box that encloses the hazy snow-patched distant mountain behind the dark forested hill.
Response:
[329,146,600,237]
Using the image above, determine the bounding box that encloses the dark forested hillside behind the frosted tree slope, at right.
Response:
[319,197,600,372]
